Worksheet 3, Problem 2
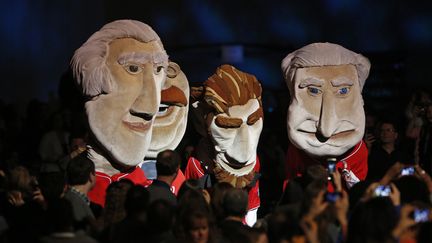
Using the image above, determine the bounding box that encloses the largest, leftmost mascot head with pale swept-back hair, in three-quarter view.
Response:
[72,20,168,167]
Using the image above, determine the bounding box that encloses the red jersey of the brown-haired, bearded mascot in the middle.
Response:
[185,156,261,211]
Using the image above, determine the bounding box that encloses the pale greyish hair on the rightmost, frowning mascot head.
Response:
[282,42,370,94]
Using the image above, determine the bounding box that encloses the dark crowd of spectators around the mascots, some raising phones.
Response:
[0,86,432,243]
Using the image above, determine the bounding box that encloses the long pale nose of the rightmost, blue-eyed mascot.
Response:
[317,92,338,142]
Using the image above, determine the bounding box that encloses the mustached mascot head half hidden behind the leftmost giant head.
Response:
[146,62,189,158]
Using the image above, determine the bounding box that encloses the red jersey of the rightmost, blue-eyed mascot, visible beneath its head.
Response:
[285,141,368,187]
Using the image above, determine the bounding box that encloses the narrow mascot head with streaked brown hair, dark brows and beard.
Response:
[193,65,263,187]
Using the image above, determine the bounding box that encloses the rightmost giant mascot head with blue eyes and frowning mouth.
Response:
[282,43,370,157]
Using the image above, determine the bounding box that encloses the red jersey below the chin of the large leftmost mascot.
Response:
[87,167,152,207]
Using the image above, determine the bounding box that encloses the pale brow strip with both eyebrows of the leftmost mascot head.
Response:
[117,52,168,66]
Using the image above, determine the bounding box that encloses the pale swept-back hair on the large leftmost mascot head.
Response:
[71,20,168,97]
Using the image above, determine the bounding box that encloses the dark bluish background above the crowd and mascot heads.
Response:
[0,0,432,114]
